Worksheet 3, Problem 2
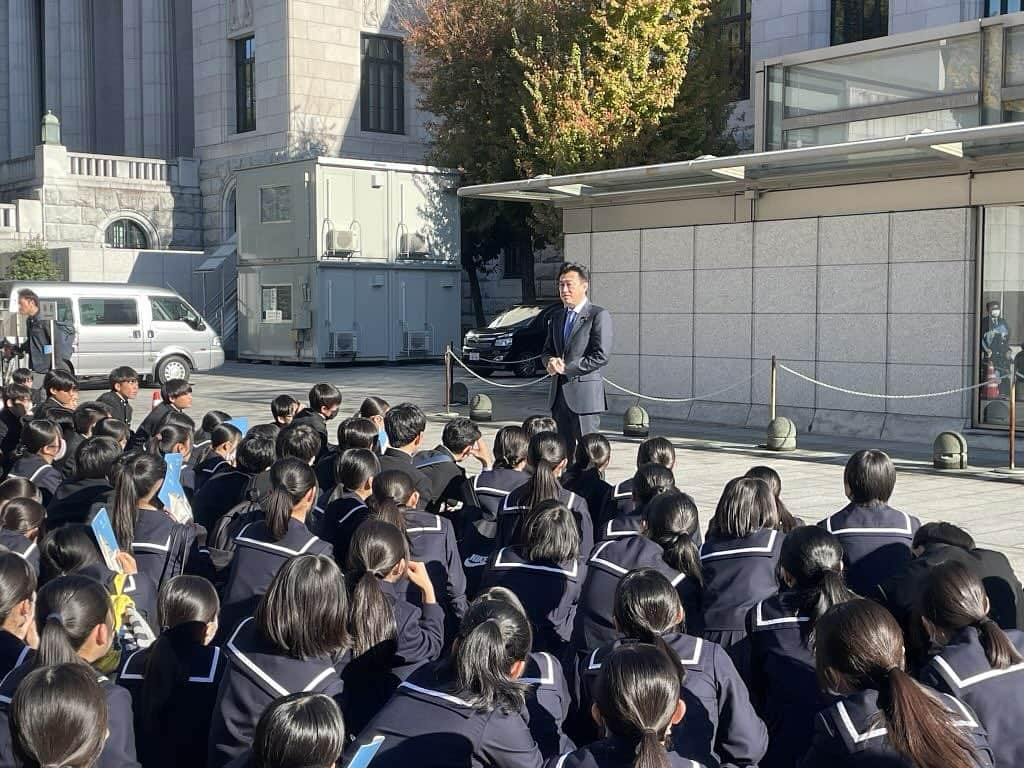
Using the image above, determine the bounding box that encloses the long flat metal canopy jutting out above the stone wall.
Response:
[459,123,1024,205]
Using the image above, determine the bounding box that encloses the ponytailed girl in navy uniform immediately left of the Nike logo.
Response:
[373,468,467,636]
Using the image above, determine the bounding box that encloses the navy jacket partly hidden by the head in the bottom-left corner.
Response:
[0,664,139,768]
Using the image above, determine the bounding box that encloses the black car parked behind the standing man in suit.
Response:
[462,302,560,377]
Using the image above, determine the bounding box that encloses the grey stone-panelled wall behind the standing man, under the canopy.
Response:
[565,208,975,438]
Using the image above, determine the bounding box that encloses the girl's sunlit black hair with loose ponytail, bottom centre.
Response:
[452,600,534,714]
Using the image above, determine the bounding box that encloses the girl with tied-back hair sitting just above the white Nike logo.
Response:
[457,426,529,595]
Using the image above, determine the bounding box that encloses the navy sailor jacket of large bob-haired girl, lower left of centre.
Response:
[207,617,348,768]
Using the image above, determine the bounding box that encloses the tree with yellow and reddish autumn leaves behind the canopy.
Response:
[407,0,732,315]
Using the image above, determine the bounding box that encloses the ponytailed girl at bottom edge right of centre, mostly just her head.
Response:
[548,643,700,768]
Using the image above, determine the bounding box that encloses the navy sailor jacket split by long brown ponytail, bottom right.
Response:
[799,689,993,768]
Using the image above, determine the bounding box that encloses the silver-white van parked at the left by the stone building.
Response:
[0,281,224,384]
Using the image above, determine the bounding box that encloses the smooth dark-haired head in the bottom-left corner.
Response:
[10,664,109,768]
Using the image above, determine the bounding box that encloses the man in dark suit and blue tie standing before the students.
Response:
[541,262,611,457]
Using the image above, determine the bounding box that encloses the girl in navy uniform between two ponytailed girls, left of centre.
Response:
[314,449,380,568]
